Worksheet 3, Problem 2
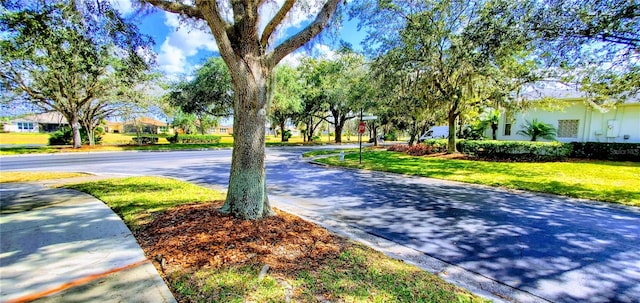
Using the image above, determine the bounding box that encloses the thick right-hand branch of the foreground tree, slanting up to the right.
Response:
[266,0,342,68]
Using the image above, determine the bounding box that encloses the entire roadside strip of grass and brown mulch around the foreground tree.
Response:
[63,177,485,302]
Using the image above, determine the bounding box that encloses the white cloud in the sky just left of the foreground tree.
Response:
[158,13,218,75]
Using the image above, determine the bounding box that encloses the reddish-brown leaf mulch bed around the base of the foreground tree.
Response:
[134,201,350,274]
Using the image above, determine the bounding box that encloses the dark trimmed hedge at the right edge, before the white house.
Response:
[571,142,640,162]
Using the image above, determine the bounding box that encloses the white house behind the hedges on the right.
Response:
[487,85,640,143]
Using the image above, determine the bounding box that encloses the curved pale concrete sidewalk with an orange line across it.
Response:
[0,183,175,302]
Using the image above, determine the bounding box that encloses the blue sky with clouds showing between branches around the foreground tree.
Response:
[113,0,365,76]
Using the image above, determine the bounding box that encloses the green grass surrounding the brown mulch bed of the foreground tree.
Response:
[65,177,486,302]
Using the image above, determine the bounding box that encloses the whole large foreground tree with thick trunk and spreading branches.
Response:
[142,0,341,219]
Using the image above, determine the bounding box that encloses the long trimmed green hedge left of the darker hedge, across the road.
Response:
[457,140,572,161]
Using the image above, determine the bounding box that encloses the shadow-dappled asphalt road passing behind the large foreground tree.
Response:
[0,148,640,302]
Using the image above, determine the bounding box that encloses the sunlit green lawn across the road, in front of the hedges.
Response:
[317,151,640,206]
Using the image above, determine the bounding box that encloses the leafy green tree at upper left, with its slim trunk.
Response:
[0,1,152,147]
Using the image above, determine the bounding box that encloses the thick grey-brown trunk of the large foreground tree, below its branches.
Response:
[221,61,274,220]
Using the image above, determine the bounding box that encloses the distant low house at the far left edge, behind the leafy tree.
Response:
[2,112,69,133]
